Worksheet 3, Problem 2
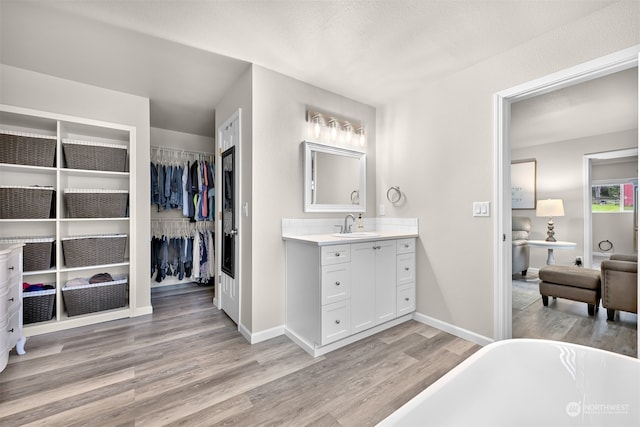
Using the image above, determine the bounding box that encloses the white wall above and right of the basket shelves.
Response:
[0,64,151,314]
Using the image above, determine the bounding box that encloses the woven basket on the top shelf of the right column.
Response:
[62,139,127,172]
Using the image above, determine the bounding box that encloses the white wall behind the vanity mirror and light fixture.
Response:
[250,66,376,332]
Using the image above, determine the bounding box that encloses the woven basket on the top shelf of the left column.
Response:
[0,130,56,167]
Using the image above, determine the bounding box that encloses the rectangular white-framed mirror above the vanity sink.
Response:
[303,141,367,212]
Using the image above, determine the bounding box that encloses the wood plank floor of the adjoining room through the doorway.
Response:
[512,273,638,357]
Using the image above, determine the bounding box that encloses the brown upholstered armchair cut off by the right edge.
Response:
[600,254,638,320]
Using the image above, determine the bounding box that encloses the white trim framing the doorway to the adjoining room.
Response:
[493,45,640,354]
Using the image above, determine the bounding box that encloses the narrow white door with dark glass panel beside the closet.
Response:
[216,110,240,324]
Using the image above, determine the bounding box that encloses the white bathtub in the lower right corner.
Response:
[378,339,640,427]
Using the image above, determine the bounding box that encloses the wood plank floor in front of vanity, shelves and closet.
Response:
[0,285,480,427]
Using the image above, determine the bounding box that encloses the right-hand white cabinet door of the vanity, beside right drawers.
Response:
[374,240,396,325]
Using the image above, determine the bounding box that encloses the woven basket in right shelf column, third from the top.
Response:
[61,234,127,267]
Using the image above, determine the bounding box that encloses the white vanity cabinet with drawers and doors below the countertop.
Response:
[285,234,415,356]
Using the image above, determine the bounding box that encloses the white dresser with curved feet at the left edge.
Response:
[0,243,25,372]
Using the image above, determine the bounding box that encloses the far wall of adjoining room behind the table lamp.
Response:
[511,129,638,268]
